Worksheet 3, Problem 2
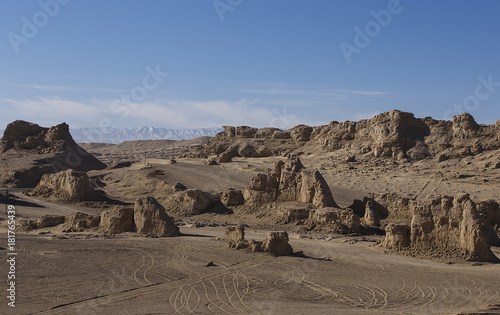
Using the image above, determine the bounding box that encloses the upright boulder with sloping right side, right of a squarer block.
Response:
[134,196,180,236]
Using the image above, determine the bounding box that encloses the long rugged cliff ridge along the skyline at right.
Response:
[189,110,500,160]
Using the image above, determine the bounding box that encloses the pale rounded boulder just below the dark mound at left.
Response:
[31,170,104,202]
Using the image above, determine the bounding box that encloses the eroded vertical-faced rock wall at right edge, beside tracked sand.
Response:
[371,194,500,261]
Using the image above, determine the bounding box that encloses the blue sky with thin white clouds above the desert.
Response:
[0,0,500,128]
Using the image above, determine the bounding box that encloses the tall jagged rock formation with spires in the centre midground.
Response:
[243,157,336,207]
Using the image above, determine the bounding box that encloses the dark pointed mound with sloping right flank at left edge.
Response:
[0,120,106,187]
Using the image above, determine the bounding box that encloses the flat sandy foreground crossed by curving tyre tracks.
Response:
[0,193,500,314]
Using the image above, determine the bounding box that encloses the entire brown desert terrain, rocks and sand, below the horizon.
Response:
[0,111,500,314]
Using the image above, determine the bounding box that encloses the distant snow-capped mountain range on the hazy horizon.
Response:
[70,127,223,144]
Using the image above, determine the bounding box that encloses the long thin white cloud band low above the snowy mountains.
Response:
[2,97,308,129]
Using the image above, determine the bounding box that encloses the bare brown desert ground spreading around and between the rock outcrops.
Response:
[0,114,500,314]
